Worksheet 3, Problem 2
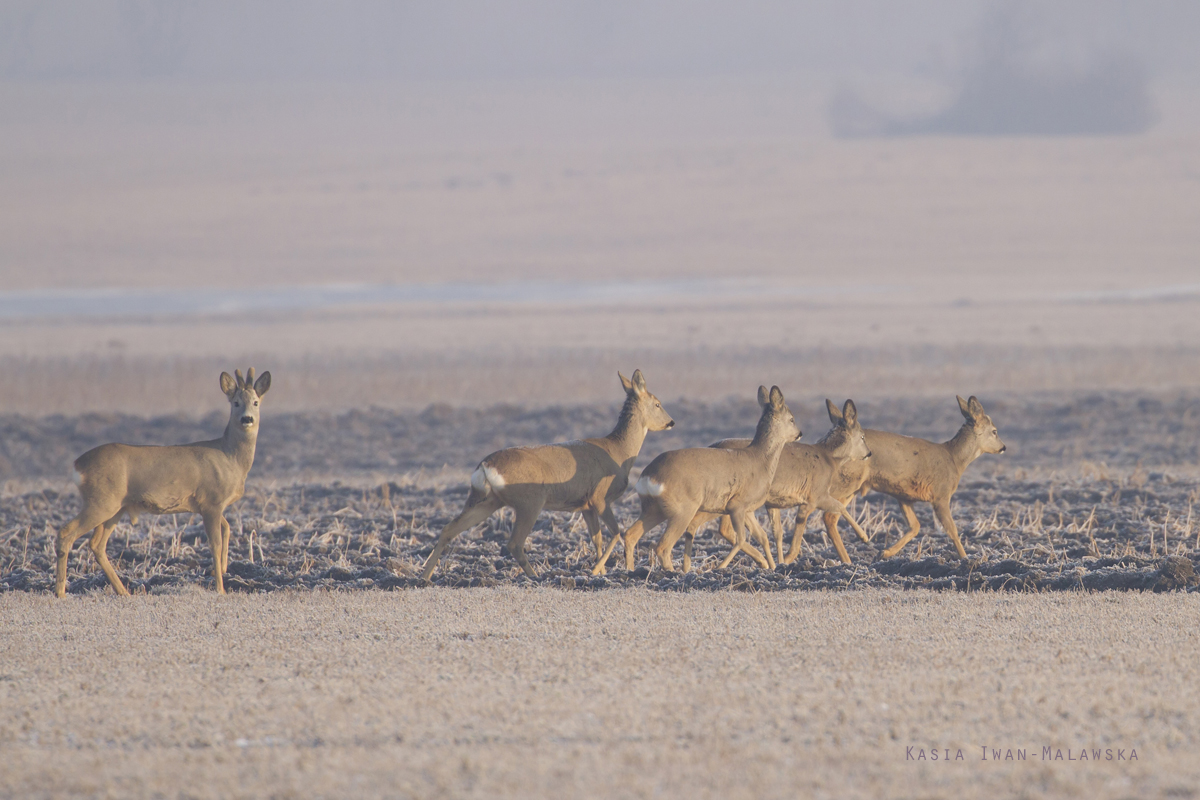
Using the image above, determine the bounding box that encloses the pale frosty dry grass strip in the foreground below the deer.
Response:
[0,589,1200,798]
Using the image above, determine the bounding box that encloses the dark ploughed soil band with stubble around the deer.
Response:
[0,393,1200,593]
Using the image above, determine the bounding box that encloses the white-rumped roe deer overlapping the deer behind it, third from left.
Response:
[593,386,800,575]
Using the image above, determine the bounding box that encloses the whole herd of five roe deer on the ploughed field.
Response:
[55,368,1006,597]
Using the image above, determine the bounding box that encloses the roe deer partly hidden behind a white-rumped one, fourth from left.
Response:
[683,399,871,572]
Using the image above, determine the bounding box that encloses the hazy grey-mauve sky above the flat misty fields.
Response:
[7,0,1200,80]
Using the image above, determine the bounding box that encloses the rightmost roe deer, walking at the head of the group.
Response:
[840,396,1008,559]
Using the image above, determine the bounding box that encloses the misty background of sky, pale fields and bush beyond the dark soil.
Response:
[0,0,1200,413]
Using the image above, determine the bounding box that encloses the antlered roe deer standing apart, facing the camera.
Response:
[55,367,271,597]
